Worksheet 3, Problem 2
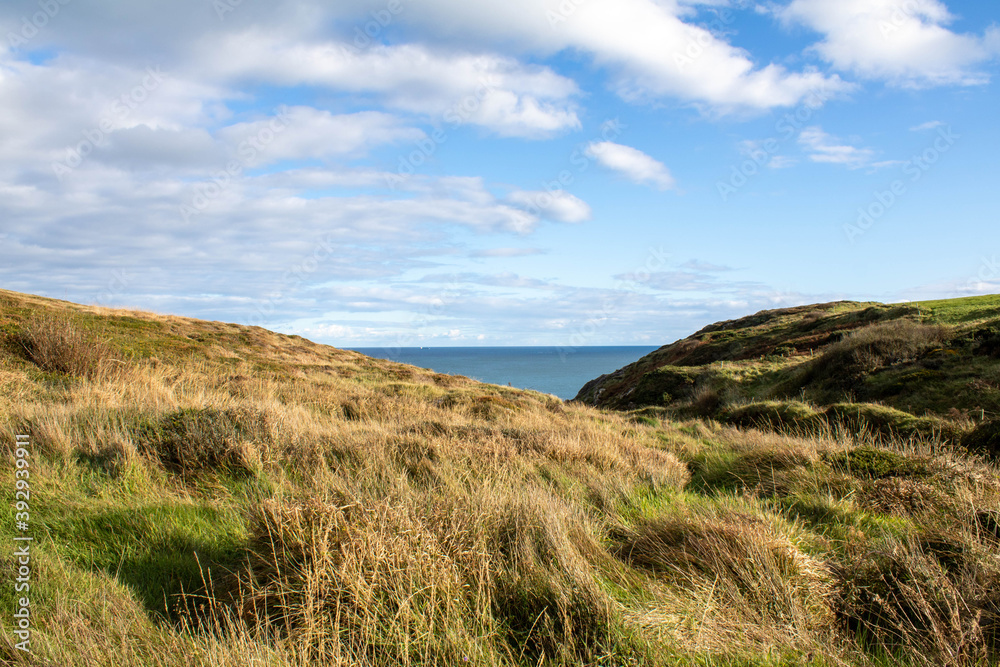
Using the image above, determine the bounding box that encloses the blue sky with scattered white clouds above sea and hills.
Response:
[0,0,1000,347]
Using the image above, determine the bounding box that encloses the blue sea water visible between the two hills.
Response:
[353,345,657,399]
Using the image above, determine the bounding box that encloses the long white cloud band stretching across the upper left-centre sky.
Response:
[197,30,580,137]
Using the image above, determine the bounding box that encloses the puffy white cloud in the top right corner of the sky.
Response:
[779,0,1000,87]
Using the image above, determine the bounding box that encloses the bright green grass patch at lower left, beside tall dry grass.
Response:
[0,458,247,617]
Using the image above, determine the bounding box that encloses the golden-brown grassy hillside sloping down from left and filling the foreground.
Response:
[0,291,1000,667]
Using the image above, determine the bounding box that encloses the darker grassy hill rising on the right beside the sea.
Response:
[577,296,1000,452]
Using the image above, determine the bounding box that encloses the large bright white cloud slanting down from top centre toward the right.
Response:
[336,0,851,112]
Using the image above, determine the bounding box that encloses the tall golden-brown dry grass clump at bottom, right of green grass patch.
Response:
[229,500,494,665]
